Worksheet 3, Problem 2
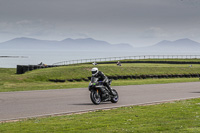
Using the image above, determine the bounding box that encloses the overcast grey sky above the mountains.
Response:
[0,0,200,47]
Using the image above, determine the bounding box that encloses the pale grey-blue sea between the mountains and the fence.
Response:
[0,49,200,68]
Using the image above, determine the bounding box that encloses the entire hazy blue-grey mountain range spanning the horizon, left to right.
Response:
[0,37,200,51]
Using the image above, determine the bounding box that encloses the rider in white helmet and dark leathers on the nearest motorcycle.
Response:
[91,67,115,96]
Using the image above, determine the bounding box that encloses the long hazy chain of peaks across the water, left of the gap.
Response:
[0,37,133,51]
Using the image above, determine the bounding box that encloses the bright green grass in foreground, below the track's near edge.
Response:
[0,99,200,133]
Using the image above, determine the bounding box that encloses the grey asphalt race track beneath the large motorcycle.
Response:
[0,82,200,121]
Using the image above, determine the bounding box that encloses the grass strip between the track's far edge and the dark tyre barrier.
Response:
[0,78,199,92]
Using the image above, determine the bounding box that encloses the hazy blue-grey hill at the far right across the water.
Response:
[148,38,200,51]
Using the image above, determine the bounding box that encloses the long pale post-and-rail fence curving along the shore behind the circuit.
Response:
[53,55,200,66]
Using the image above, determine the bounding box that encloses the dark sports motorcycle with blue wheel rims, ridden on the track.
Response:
[88,77,119,105]
